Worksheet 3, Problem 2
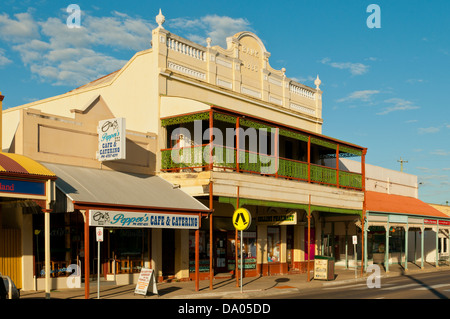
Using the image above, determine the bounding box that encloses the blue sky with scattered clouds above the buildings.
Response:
[0,0,450,204]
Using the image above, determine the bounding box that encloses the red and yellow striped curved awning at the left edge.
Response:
[0,152,56,179]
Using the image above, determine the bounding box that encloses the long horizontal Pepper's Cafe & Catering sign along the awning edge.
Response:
[89,209,199,229]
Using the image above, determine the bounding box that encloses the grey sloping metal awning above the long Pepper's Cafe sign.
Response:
[42,163,209,212]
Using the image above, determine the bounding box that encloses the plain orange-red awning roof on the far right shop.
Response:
[366,191,449,219]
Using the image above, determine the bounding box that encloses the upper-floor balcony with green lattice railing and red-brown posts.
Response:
[161,109,365,190]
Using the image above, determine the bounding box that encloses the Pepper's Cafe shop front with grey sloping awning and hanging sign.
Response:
[39,163,209,298]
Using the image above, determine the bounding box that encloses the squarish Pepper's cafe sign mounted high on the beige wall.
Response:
[97,117,126,161]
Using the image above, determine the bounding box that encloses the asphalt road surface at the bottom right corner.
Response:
[268,271,450,299]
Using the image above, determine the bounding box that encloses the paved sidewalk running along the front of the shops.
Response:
[21,264,450,299]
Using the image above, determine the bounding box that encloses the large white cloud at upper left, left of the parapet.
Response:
[7,12,153,86]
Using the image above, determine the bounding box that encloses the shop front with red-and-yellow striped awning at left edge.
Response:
[0,153,56,292]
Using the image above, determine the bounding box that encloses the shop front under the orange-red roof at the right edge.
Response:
[364,191,450,272]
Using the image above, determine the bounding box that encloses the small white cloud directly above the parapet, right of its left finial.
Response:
[166,15,251,48]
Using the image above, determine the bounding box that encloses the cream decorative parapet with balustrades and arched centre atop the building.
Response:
[152,10,322,125]
